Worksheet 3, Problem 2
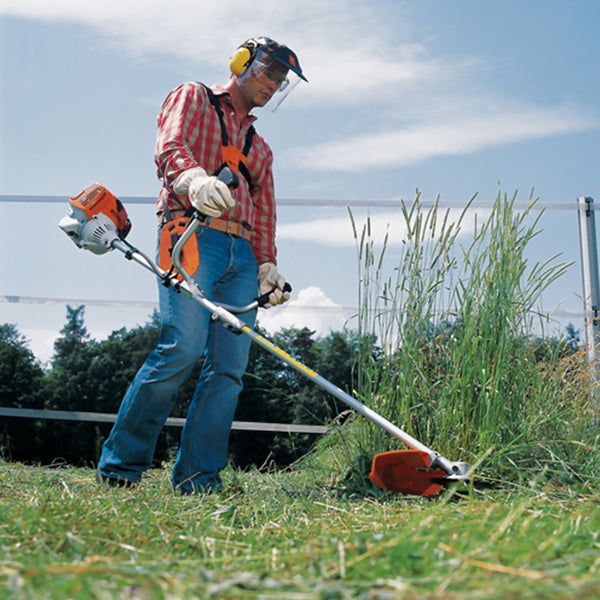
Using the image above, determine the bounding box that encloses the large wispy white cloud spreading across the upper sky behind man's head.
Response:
[0,0,598,166]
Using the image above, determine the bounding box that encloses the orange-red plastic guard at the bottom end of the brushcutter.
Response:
[369,450,446,496]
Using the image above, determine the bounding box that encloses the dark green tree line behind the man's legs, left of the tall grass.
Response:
[0,306,378,467]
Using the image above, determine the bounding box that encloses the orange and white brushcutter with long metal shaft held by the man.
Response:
[59,168,470,496]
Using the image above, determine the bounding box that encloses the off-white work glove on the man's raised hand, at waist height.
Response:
[173,167,235,218]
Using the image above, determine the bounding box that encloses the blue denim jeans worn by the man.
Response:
[98,227,258,493]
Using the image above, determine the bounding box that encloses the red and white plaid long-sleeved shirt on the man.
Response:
[154,82,277,265]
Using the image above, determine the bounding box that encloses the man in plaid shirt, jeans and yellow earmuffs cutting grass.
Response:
[98,38,306,494]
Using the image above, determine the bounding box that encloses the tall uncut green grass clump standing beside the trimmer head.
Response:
[351,192,598,490]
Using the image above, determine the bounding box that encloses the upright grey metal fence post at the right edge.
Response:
[577,196,600,381]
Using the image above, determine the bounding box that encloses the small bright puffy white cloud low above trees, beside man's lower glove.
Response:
[258,286,352,337]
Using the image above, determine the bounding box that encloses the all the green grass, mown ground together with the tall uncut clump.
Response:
[0,186,600,600]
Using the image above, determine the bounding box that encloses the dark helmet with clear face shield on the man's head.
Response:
[243,44,307,112]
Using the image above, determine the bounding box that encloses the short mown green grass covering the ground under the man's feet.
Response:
[0,456,600,600]
